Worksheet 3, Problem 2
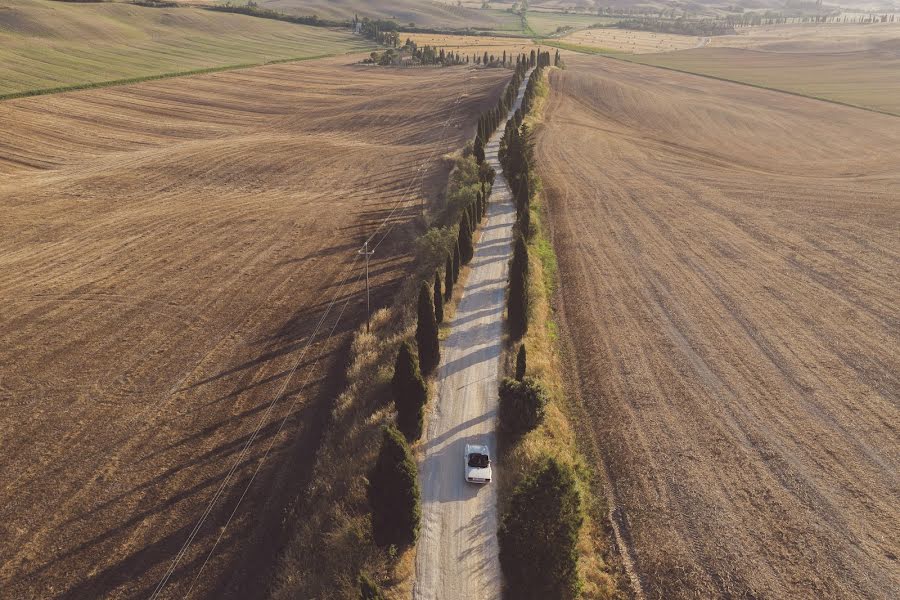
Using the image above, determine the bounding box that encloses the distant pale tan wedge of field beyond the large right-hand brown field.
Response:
[628,23,900,114]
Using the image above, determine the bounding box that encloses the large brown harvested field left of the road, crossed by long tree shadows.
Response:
[0,59,508,599]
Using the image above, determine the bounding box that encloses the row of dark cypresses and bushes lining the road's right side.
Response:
[497,52,583,600]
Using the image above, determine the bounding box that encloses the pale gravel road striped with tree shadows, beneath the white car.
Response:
[413,69,527,600]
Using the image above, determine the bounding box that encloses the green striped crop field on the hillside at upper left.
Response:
[0,0,371,96]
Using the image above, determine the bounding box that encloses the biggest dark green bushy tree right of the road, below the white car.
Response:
[498,458,583,600]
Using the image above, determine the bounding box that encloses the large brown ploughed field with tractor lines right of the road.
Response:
[537,57,900,599]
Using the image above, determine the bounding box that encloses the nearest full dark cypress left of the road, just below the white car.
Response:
[368,427,422,547]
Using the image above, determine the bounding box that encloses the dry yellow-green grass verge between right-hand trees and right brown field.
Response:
[499,69,627,600]
